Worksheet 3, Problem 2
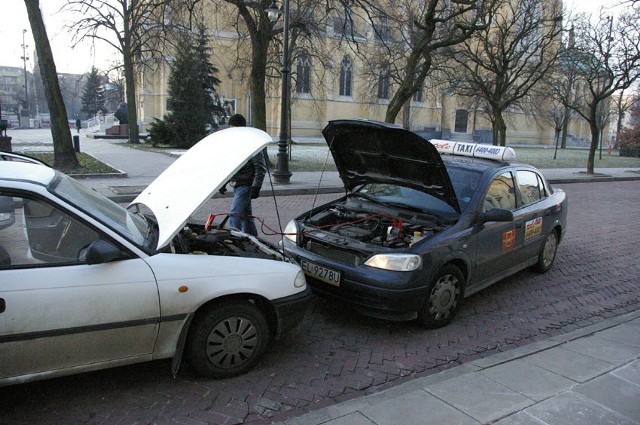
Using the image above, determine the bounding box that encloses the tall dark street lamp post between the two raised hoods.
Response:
[266,0,292,184]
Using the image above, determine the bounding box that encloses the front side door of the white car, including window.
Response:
[0,192,160,383]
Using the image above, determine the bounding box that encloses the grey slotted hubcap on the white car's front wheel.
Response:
[207,317,258,369]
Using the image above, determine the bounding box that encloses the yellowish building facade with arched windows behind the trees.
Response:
[137,0,590,145]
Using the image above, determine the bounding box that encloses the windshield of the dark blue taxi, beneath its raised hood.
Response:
[354,183,458,219]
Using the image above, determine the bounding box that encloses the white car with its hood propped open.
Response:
[0,128,310,386]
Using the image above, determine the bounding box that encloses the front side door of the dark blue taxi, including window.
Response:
[473,172,522,286]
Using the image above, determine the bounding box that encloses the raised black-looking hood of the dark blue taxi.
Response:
[322,120,460,212]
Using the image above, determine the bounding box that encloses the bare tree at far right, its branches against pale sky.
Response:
[570,9,640,174]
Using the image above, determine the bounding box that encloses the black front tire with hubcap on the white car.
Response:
[187,302,270,378]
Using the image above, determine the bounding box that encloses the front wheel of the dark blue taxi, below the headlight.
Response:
[418,265,464,329]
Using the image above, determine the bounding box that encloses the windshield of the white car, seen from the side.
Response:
[50,173,150,247]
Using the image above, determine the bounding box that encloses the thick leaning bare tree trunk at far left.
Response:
[24,0,80,168]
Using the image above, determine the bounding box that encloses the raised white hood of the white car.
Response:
[130,127,272,249]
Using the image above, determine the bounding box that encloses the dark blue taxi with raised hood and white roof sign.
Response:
[284,120,567,328]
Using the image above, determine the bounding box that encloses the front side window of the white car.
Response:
[0,196,99,268]
